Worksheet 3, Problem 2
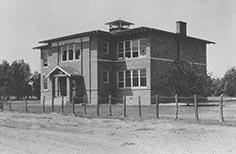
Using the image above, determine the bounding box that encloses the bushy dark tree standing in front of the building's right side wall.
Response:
[167,61,212,96]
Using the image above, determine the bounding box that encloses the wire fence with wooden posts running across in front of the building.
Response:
[0,95,234,122]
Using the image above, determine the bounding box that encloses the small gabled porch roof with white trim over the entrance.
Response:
[46,66,82,77]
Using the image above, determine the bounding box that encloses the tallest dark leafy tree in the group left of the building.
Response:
[10,59,31,99]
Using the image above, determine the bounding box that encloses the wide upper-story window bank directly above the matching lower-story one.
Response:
[117,39,147,59]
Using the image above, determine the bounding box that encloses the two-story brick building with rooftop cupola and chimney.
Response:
[34,20,214,104]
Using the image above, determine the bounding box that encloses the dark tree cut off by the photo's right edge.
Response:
[222,67,236,96]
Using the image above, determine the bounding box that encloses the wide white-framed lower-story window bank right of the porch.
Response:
[117,69,147,88]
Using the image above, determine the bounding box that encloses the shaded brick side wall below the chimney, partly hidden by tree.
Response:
[150,33,206,103]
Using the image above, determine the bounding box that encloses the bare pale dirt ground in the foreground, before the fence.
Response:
[0,112,236,154]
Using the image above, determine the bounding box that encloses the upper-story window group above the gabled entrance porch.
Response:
[61,43,81,61]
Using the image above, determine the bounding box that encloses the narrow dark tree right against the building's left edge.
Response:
[31,72,40,99]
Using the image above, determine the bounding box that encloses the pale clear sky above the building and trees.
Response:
[0,0,236,77]
